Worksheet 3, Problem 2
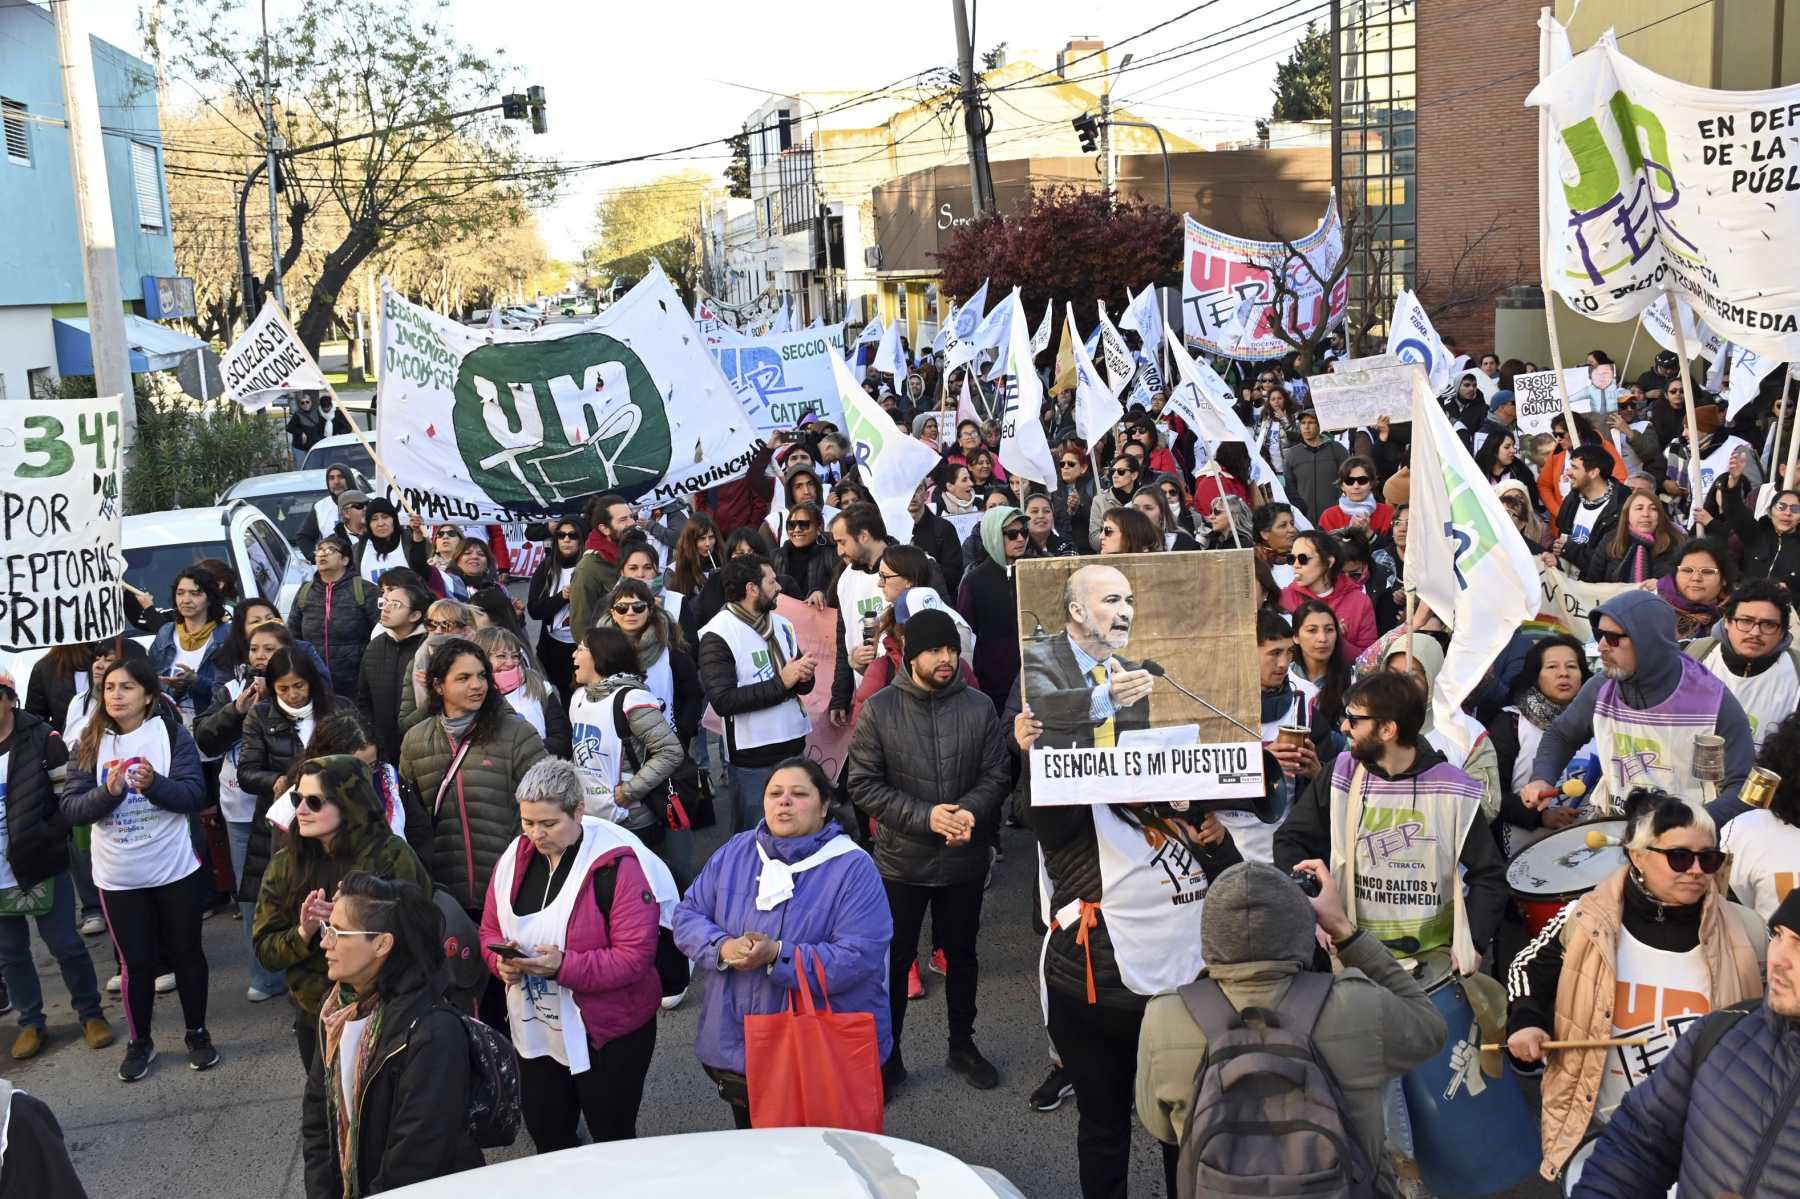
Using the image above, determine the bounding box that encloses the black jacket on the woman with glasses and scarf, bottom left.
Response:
[301,990,484,1199]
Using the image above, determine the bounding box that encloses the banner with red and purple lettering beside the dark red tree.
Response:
[1181,194,1350,360]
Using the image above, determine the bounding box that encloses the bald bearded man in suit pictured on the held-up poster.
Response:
[1024,565,1156,749]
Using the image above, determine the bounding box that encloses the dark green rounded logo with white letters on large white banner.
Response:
[450,333,671,508]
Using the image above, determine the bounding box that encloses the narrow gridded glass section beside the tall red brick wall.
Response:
[1332,0,1418,336]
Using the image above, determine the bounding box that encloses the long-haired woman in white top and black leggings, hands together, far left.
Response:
[61,657,220,1082]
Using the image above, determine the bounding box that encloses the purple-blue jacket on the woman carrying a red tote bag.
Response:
[675,821,895,1073]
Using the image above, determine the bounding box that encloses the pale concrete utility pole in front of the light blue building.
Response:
[50,0,137,446]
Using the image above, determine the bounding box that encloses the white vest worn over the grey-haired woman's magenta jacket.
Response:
[493,817,607,1075]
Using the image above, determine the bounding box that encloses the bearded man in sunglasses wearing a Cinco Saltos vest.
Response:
[1274,666,1512,978]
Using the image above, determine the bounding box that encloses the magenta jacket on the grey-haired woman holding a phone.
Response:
[481,837,662,1050]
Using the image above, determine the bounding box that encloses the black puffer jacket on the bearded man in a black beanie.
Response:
[850,673,1012,888]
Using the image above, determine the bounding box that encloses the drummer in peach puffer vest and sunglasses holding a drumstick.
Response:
[1507,787,1768,1179]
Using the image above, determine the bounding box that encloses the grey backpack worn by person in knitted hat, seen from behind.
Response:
[1175,970,1377,1199]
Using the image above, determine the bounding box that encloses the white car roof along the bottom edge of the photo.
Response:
[391,1129,1024,1199]
